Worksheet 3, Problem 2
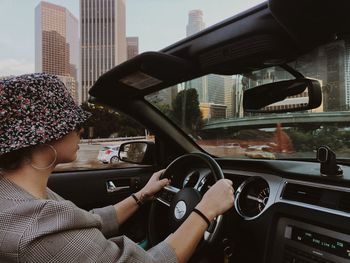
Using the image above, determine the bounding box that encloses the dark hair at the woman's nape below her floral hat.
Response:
[0,146,35,172]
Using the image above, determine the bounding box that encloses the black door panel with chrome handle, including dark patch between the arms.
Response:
[48,166,154,242]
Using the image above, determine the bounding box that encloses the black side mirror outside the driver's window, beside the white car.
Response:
[118,141,155,165]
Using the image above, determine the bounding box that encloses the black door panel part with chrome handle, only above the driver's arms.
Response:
[48,167,153,210]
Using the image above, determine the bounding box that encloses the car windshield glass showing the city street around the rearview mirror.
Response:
[146,38,350,161]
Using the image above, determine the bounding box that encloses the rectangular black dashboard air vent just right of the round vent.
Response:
[282,183,323,205]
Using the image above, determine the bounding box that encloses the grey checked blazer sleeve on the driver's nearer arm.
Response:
[19,202,177,263]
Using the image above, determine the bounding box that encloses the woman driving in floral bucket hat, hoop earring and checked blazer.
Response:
[0,73,234,263]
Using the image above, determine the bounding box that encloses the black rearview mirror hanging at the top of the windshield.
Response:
[243,78,322,113]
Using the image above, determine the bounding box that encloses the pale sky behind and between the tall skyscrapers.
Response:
[0,0,263,76]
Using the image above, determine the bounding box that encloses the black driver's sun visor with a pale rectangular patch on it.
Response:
[89,52,195,101]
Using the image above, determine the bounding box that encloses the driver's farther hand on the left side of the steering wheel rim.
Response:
[136,169,170,202]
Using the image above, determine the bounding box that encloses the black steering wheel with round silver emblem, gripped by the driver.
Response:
[148,153,224,250]
